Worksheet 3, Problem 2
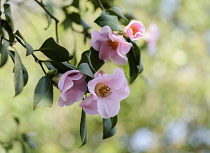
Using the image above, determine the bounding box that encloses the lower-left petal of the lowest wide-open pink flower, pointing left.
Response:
[79,94,98,115]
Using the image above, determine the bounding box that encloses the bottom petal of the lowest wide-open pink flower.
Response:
[97,94,120,118]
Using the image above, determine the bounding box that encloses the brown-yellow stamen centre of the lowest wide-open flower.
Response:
[95,84,112,98]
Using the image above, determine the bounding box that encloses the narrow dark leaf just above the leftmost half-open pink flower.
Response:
[44,61,77,73]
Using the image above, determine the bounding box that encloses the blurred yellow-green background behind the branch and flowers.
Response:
[0,0,210,153]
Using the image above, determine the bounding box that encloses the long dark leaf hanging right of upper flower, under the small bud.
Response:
[127,41,144,84]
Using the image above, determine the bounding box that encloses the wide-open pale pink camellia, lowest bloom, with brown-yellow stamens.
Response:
[80,68,130,118]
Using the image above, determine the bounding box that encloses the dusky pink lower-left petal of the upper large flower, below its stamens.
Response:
[99,41,116,62]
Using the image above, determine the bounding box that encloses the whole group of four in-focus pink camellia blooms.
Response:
[58,20,145,118]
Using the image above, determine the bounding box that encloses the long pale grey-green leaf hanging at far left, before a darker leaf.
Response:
[14,51,24,96]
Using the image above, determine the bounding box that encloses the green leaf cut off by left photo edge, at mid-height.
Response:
[0,41,9,67]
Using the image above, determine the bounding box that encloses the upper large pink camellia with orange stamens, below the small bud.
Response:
[90,26,132,65]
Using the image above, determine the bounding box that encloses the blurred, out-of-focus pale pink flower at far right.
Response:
[143,23,160,56]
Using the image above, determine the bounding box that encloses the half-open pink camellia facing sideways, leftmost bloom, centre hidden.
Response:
[58,70,87,107]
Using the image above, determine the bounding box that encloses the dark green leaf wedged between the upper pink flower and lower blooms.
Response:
[78,48,104,73]
